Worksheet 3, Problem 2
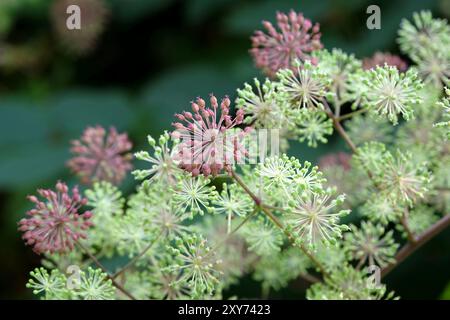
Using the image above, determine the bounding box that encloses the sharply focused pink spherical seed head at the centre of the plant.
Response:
[172,95,249,176]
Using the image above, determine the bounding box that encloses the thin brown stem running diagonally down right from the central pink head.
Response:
[231,170,329,276]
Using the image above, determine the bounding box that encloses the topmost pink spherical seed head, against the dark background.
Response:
[250,10,323,77]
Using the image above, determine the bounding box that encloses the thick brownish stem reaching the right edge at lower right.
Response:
[381,214,450,277]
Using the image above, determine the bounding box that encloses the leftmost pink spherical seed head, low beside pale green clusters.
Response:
[19,182,92,254]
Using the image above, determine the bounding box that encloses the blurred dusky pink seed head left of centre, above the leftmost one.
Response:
[68,126,132,184]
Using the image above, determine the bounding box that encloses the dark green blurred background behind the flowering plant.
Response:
[0,0,450,299]
